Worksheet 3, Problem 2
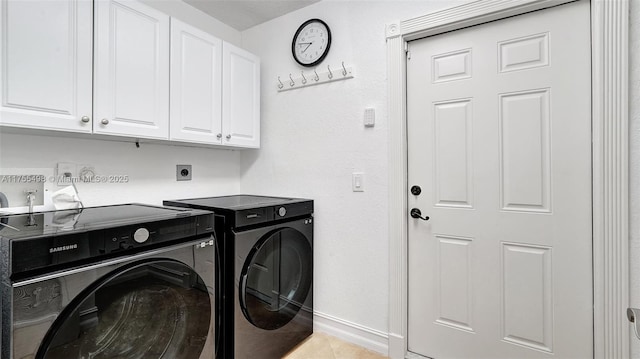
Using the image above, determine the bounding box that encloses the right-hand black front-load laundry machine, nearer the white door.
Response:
[164,195,313,359]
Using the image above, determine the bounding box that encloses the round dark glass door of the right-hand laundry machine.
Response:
[239,228,313,330]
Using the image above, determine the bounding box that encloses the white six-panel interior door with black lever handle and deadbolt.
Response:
[407,1,593,358]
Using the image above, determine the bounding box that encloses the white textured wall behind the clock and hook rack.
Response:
[241,1,468,348]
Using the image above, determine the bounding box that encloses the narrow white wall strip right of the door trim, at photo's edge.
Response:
[629,1,640,358]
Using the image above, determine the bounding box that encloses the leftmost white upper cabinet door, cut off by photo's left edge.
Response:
[0,0,92,132]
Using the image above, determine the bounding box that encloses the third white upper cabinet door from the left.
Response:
[170,19,222,144]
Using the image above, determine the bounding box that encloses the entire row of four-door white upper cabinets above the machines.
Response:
[0,0,260,148]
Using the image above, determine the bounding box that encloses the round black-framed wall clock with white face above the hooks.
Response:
[291,19,331,66]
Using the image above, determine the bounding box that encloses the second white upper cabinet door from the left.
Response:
[93,0,169,139]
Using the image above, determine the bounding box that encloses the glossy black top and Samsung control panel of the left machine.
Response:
[0,204,214,280]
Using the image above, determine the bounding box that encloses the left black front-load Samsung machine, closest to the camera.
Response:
[0,204,221,359]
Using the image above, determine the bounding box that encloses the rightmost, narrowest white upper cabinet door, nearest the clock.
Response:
[222,42,260,148]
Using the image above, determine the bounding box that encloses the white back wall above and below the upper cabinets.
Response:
[0,0,241,211]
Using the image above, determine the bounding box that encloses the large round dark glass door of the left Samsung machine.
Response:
[37,260,212,359]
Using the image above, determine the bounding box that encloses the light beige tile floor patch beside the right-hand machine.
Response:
[283,333,387,359]
